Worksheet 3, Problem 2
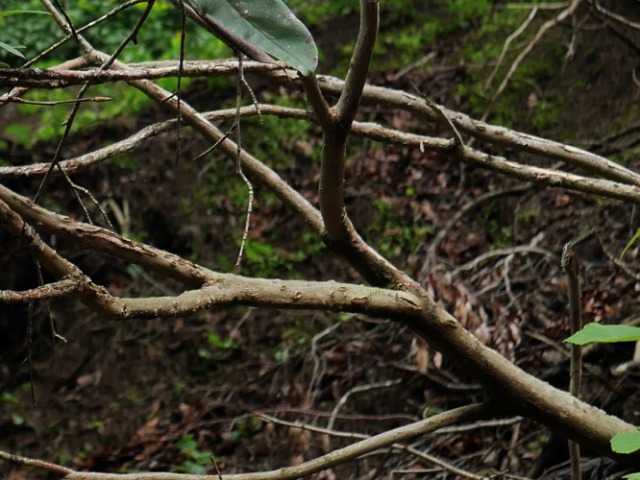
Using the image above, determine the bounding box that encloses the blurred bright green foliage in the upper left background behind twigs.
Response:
[0,0,231,148]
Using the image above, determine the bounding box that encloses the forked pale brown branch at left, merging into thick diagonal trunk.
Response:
[0,185,421,320]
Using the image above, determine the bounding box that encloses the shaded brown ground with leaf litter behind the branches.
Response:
[0,4,640,480]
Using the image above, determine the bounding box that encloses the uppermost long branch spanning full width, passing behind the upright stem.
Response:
[0,60,640,190]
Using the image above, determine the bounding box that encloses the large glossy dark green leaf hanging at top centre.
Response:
[187,0,318,75]
